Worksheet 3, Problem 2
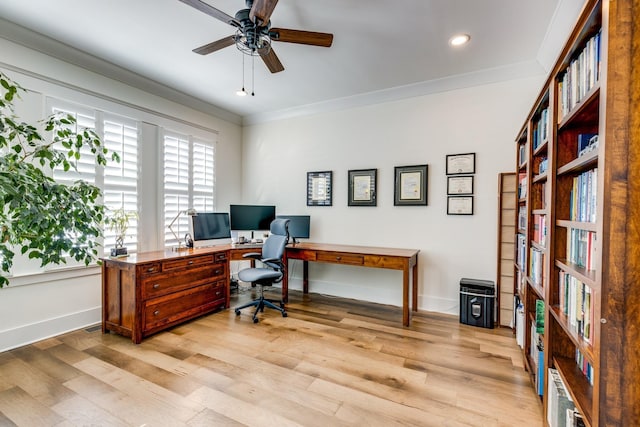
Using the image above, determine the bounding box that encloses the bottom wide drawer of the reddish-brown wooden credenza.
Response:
[143,280,226,332]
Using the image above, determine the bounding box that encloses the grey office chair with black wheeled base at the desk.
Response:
[235,219,289,323]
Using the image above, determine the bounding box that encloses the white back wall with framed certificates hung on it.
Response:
[243,77,540,313]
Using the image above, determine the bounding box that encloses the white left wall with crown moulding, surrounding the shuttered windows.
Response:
[0,38,242,351]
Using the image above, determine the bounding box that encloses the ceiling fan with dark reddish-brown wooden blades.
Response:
[180,0,333,73]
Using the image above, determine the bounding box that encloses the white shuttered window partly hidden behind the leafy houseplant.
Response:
[49,99,138,254]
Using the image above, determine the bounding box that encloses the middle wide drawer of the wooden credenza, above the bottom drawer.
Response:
[142,264,227,299]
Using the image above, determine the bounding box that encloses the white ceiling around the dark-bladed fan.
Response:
[0,0,575,121]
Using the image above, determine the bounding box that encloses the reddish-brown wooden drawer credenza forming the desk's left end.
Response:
[102,246,230,344]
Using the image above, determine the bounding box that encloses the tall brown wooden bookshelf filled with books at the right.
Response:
[514,0,640,426]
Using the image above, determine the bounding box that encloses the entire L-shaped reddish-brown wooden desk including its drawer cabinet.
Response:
[102,243,419,344]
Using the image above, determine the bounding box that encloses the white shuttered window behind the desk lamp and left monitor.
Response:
[163,133,215,247]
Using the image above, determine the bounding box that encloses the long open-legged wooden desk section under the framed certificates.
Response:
[282,243,420,326]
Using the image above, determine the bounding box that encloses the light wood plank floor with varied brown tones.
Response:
[0,288,542,427]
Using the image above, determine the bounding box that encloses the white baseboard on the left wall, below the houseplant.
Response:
[0,307,102,352]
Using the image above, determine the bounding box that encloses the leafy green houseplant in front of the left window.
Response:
[0,72,119,287]
